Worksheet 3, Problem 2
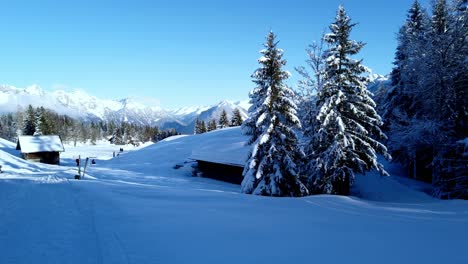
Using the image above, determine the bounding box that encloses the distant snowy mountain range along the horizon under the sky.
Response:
[0,85,249,134]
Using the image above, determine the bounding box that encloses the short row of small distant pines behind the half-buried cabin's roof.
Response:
[193,108,244,134]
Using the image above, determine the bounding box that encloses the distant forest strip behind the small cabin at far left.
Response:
[0,105,178,144]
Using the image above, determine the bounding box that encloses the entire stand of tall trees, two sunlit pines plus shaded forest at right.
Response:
[241,0,468,199]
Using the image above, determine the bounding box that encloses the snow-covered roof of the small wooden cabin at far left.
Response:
[16,136,65,153]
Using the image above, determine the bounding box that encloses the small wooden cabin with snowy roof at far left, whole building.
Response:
[16,135,65,165]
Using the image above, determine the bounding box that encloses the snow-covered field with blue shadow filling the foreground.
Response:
[0,129,468,264]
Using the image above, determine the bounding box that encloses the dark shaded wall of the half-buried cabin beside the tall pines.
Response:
[197,160,244,184]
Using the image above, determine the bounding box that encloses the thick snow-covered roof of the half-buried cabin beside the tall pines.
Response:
[190,127,250,167]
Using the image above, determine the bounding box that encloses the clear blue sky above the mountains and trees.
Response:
[0,0,428,108]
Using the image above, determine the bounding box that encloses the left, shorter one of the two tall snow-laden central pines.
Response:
[241,32,307,196]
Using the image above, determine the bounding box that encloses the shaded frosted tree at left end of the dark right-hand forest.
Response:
[380,0,432,179]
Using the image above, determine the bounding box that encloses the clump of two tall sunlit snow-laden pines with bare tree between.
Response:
[241,6,390,196]
